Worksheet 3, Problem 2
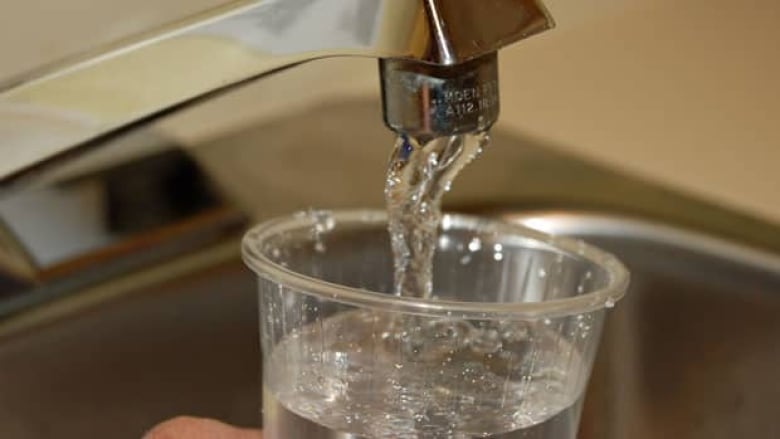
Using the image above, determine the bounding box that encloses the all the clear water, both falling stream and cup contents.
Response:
[261,132,587,439]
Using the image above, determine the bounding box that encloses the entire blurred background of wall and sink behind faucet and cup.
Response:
[0,0,780,439]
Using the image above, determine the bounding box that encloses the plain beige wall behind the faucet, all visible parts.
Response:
[0,0,780,223]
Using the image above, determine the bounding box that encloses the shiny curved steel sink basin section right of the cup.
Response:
[505,211,780,439]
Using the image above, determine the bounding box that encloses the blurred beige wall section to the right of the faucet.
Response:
[504,0,780,223]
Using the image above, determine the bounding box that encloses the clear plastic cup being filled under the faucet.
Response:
[243,211,628,439]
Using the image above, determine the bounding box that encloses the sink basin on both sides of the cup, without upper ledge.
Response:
[0,211,780,439]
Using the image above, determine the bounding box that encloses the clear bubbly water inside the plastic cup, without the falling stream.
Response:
[263,310,586,438]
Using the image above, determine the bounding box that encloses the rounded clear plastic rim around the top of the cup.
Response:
[241,209,629,320]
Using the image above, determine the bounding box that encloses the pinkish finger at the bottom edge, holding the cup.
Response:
[143,416,261,439]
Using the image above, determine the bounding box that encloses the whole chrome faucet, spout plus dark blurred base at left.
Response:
[0,0,553,296]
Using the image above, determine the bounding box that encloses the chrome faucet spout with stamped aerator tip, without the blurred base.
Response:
[0,0,553,186]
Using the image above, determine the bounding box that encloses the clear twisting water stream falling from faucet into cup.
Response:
[385,132,489,298]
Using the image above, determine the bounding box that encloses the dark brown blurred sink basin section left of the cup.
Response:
[0,249,260,439]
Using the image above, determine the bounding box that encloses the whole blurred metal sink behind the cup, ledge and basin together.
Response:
[0,102,780,439]
